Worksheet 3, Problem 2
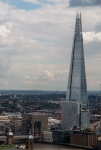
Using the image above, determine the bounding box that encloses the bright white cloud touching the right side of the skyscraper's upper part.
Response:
[83,31,101,42]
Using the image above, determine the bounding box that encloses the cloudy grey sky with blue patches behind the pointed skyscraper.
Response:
[0,0,101,90]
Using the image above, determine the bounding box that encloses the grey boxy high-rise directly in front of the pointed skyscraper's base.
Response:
[61,101,81,128]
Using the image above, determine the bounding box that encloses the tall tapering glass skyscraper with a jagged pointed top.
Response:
[66,13,88,108]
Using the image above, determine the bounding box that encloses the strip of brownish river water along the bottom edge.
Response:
[34,143,83,150]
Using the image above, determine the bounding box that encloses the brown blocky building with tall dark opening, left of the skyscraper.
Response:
[22,113,48,136]
